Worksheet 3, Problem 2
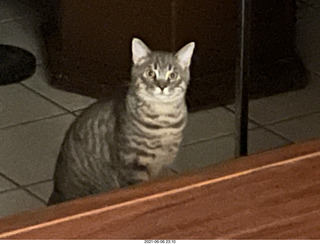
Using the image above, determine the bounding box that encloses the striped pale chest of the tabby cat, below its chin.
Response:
[122,99,187,153]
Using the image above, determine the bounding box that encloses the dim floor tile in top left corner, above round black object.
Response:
[0,0,34,24]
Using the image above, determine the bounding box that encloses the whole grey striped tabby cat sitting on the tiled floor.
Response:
[49,38,195,204]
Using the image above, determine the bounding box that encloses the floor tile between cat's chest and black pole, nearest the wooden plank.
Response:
[171,135,234,172]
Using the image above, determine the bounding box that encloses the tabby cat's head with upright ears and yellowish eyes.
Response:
[132,38,194,102]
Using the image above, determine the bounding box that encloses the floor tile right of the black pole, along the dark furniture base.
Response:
[229,74,320,125]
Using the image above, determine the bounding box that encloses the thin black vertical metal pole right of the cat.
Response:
[235,0,251,157]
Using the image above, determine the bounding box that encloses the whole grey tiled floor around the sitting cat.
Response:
[0,0,320,217]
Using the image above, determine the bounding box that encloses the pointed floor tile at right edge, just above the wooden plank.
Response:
[267,113,320,142]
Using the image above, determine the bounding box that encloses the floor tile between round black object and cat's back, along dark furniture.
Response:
[22,67,96,111]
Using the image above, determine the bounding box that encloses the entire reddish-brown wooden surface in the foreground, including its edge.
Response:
[0,140,320,239]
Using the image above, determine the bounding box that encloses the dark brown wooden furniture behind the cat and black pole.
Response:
[41,0,306,111]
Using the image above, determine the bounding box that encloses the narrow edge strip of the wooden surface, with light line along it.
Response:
[0,139,320,239]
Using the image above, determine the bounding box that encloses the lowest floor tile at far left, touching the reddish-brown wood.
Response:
[0,189,45,218]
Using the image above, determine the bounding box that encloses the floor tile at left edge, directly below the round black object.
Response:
[0,84,66,128]
